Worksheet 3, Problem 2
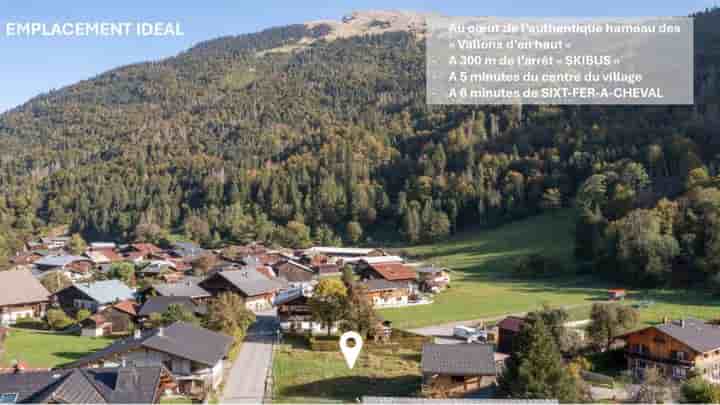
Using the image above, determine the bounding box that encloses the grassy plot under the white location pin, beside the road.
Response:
[273,338,421,403]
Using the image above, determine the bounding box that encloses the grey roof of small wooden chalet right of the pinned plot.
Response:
[421,343,497,376]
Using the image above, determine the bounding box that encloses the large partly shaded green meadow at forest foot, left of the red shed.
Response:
[381,210,609,328]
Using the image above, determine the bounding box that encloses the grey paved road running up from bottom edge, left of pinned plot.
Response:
[221,312,277,403]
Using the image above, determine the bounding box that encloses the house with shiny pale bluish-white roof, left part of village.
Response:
[53,280,135,313]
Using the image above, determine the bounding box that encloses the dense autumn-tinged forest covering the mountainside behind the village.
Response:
[0,9,720,283]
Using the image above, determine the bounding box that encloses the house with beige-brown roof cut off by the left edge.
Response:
[0,270,50,325]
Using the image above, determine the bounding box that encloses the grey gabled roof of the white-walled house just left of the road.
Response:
[68,322,233,367]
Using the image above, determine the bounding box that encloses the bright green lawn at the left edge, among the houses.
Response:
[0,329,112,368]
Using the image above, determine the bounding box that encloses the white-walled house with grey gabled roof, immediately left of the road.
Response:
[67,322,233,394]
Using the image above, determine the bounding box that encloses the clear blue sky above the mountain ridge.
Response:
[0,0,720,112]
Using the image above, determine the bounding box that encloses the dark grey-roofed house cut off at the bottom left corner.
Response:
[0,366,173,404]
